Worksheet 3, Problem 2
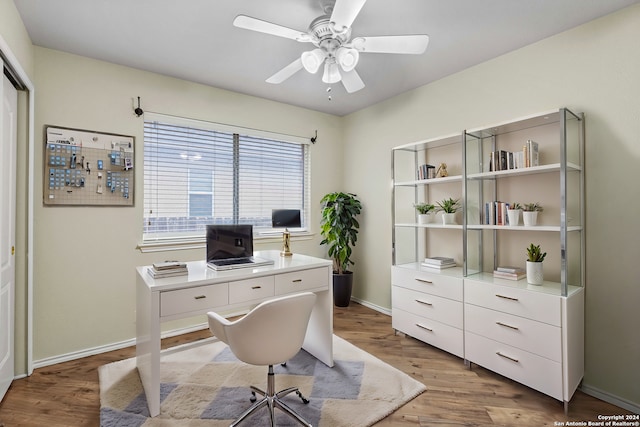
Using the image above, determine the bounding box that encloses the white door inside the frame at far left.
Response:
[0,61,18,400]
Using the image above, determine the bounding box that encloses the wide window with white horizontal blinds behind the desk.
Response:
[143,114,316,242]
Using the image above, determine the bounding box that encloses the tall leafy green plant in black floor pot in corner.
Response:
[320,192,362,307]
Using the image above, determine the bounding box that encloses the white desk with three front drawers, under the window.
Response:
[136,251,333,417]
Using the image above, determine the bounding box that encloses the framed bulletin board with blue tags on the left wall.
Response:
[42,126,135,206]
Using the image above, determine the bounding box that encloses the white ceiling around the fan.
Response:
[15,0,640,115]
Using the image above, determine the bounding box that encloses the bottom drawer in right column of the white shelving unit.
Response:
[464,332,563,400]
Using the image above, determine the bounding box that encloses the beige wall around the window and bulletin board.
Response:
[34,47,342,361]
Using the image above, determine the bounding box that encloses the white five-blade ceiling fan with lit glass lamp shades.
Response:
[233,0,429,93]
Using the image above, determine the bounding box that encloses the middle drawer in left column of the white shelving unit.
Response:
[392,286,463,329]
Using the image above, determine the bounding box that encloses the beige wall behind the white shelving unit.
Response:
[344,5,640,407]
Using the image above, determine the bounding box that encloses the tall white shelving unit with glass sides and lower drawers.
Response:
[392,108,585,410]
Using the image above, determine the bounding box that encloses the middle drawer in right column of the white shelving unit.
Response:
[464,304,562,362]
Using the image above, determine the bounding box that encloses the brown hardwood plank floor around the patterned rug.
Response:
[0,303,629,427]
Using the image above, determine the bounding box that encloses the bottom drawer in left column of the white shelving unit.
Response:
[392,308,463,357]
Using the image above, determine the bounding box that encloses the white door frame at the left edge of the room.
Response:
[0,35,35,375]
